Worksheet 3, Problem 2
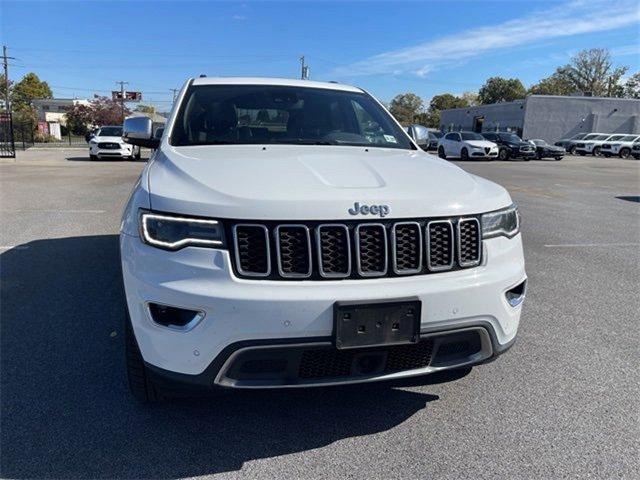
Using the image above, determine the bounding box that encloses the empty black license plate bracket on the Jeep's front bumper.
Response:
[333,299,422,349]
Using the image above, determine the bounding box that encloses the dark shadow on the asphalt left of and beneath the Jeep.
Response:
[0,235,465,479]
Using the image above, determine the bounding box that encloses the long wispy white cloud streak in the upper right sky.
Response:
[334,0,640,76]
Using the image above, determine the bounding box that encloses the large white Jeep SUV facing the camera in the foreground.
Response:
[120,78,527,401]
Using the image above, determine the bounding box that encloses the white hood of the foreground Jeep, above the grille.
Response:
[148,144,511,220]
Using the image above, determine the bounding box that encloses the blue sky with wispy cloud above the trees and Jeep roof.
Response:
[0,0,640,109]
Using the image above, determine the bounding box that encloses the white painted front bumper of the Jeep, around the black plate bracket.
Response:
[120,234,526,386]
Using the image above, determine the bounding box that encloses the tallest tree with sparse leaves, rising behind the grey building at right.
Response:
[555,48,629,97]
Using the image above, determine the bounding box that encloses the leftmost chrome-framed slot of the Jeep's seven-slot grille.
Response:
[234,225,271,277]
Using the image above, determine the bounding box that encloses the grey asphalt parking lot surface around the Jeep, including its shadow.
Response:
[0,150,640,479]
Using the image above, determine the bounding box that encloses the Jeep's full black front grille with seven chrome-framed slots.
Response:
[229,217,482,280]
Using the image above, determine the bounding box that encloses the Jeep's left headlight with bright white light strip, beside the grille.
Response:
[140,211,225,250]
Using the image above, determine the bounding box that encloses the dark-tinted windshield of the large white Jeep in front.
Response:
[171,85,413,150]
